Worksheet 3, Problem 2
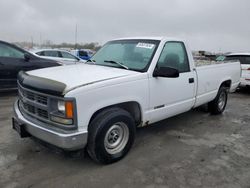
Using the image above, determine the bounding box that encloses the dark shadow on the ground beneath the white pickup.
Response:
[28,108,210,168]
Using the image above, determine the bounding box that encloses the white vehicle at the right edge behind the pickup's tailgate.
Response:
[225,53,250,87]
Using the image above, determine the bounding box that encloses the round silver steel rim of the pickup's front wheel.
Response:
[104,122,129,154]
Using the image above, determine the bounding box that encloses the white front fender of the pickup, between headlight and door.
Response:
[65,79,149,130]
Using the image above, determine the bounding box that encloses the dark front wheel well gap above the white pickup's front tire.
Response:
[89,101,141,126]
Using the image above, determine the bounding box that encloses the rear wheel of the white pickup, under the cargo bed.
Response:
[208,86,228,115]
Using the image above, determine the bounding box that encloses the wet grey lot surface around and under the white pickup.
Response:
[0,91,250,188]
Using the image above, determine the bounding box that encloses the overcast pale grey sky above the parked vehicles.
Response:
[0,0,250,52]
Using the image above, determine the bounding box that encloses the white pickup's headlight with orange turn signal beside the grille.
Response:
[51,100,74,125]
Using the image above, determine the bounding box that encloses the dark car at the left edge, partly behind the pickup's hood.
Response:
[0,41,61,91]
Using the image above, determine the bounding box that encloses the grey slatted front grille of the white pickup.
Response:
[18,85,49,120]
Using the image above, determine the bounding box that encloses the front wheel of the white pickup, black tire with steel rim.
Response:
[87,108,136,164]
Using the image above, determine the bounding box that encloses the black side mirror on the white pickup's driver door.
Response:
[153,67,179,78]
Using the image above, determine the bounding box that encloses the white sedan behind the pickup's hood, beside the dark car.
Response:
[32,49,85,65]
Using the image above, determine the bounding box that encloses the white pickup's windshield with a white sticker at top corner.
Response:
[90,40,160,72]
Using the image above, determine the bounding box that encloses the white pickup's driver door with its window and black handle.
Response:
[149,41,196,123]
